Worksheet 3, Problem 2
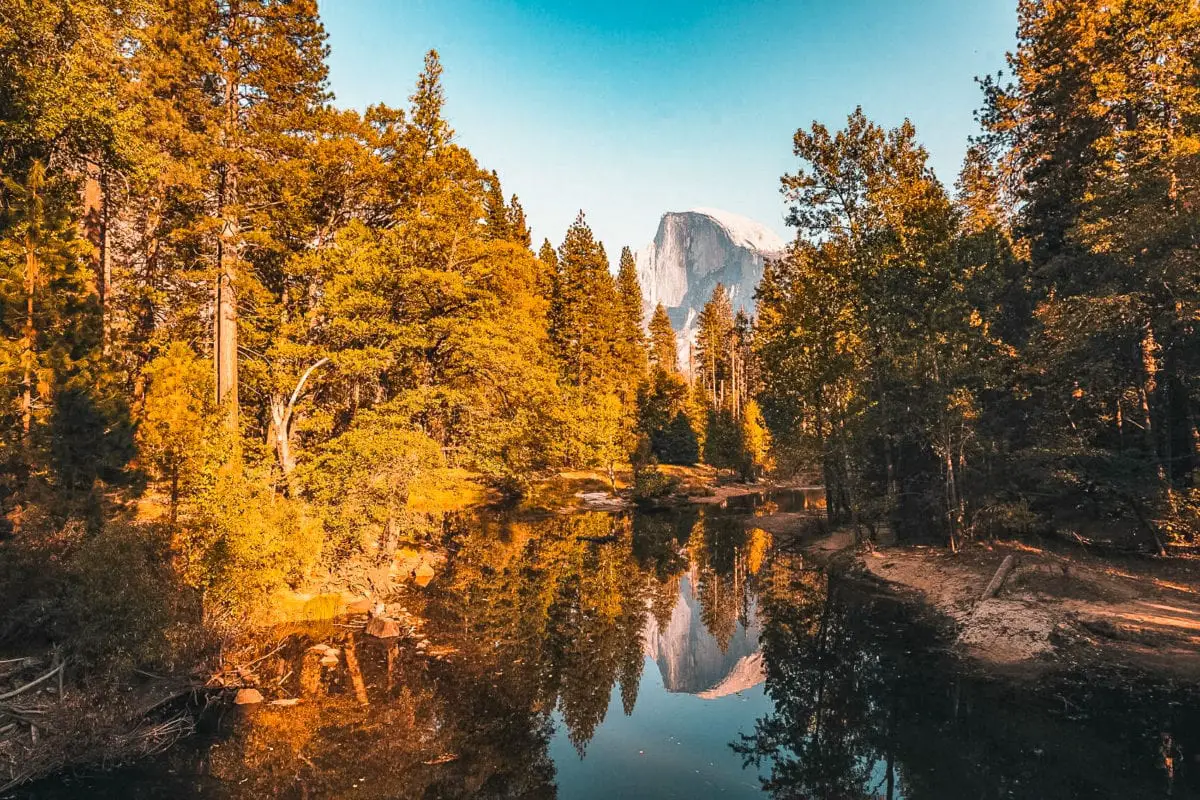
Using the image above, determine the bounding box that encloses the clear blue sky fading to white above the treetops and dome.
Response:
[320,0,1016,261]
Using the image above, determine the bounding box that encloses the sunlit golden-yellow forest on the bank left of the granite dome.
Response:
[0,0,767,676]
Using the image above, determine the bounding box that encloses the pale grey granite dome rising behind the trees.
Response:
[637,209,785,368]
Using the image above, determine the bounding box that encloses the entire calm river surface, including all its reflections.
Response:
[14,495,1200,800]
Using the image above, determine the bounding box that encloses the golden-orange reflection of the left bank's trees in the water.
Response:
[79,509,767,800]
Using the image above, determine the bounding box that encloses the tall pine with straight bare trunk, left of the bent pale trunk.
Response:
[136,0,329,429]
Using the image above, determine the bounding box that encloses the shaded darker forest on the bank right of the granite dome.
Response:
[754,0,1200,553]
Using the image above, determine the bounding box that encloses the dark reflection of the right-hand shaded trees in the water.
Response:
[731,554,1200,800]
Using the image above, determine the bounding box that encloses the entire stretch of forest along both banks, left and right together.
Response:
[0,0,1200,743]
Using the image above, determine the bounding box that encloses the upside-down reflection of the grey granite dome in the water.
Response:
[642,577,766,699]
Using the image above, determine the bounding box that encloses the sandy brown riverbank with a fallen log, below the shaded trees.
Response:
[755,515,1200,681]
